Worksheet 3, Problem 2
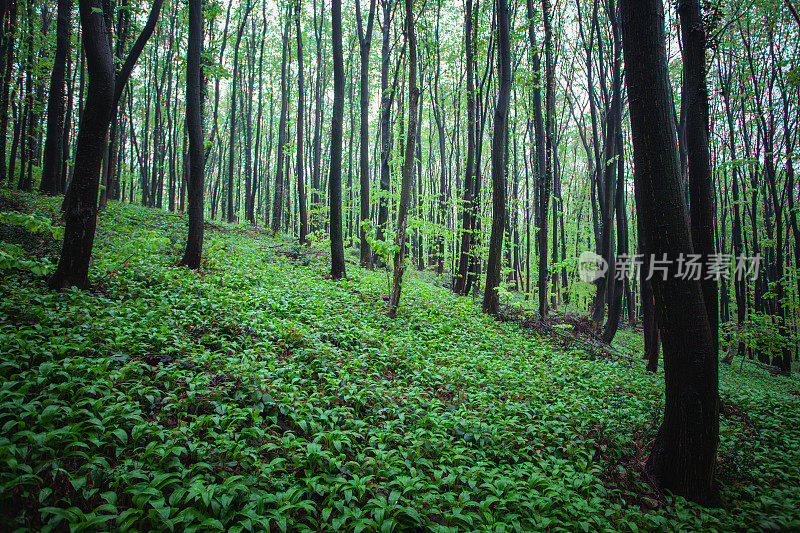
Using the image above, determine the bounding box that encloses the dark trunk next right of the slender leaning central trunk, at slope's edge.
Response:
[482,0,511,315]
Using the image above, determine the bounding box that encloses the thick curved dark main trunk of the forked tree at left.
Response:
[48,0,114,289]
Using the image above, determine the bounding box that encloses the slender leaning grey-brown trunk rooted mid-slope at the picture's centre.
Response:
[389,0,419,318]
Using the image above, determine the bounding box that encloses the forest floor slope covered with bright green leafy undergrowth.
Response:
[0,192,800,532]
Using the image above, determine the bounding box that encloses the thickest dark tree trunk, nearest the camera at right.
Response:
[620,0,719,505]
